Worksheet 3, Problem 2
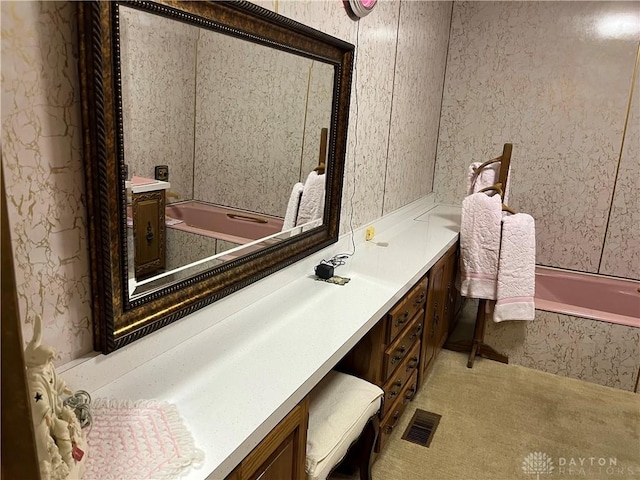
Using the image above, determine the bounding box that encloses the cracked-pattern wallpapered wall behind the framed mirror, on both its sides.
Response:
[0,0,451,364]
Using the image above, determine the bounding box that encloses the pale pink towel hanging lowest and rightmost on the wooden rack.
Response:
[493,213,536,322]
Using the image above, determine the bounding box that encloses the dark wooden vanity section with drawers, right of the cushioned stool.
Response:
[337,245,459,452]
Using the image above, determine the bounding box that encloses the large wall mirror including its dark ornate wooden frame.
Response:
[79,1,354,353]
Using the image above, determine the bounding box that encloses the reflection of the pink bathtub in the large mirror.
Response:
[165,200,283,245]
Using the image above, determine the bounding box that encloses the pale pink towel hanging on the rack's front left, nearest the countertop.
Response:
[460,193,502,300]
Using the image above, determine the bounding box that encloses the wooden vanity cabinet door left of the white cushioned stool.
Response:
[226,398,309,480]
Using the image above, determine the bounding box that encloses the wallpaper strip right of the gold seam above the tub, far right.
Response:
[600,52,640,280]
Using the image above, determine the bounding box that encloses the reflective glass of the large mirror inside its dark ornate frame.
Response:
[118,5,334,299]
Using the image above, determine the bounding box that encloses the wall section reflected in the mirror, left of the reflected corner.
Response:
[120,6,199,201]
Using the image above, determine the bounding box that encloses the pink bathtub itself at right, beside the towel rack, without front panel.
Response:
[535,267,640,328]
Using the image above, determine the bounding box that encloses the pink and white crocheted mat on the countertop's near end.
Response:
[84,399,204,480]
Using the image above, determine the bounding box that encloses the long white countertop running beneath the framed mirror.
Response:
[62,197,460,480]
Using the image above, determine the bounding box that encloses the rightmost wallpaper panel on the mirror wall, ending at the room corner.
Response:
[384,2,452,213]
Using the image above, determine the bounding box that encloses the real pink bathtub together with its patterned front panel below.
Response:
[486,267,640,391]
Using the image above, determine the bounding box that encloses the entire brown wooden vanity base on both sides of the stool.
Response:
[226,245,459,480]
